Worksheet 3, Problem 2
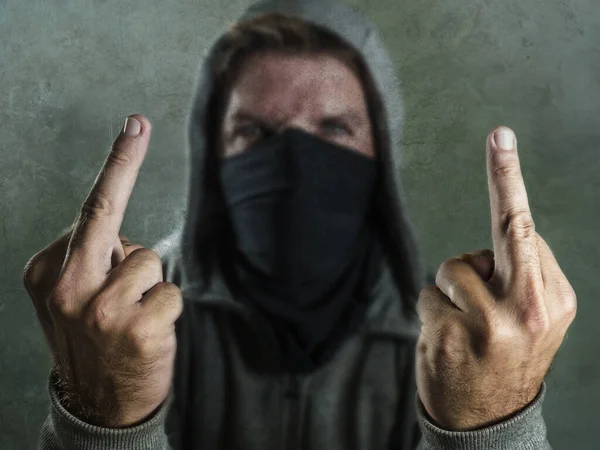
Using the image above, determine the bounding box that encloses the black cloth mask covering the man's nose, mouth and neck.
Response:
[221,129,380,372]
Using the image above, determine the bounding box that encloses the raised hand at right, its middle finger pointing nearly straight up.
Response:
[416,127,577,431]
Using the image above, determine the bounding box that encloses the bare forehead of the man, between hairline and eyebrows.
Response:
[228,53,366,120]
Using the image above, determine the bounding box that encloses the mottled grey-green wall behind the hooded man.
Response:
[0,0,600,450]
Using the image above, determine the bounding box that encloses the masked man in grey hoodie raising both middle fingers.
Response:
[25,1,576,450]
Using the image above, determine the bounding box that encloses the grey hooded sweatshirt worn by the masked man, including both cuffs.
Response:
[40,0,551,450]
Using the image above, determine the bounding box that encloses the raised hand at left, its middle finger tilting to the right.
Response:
[23,115,183,428]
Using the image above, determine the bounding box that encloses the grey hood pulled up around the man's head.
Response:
[154,0,425,320]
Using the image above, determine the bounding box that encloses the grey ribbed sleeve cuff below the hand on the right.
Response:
[417,382,552,450]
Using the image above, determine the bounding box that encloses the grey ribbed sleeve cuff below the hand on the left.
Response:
[38,372,177,450]
